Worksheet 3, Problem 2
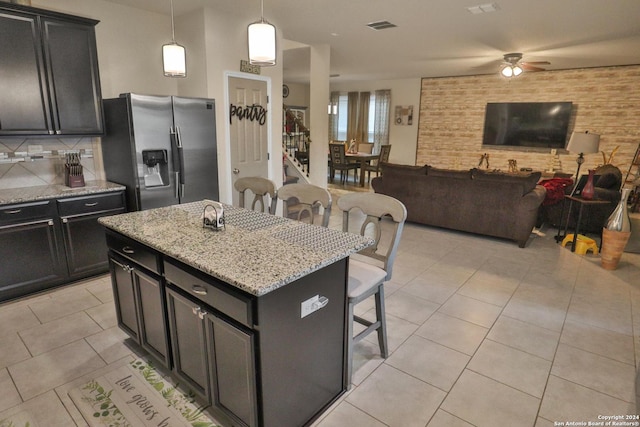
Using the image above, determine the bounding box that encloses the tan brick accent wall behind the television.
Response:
[416,66,640,181]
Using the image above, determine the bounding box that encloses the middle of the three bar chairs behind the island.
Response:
[278,183,331,227]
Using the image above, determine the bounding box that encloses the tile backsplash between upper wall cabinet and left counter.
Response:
[0,137,104,189]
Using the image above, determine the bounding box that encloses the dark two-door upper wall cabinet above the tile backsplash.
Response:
[0,2,103,137]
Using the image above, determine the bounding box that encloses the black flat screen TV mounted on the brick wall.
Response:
[482,102,573,149]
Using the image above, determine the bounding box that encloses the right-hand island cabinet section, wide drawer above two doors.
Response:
[164,259,258,427]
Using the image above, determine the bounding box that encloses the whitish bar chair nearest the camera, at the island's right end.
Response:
[337,193,407,387]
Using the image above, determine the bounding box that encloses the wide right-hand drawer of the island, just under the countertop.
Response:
[164,259,253,327]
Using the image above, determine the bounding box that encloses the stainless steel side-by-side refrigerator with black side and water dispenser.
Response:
[102,93,219,211]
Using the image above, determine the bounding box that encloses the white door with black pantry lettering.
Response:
[228,77,269,206]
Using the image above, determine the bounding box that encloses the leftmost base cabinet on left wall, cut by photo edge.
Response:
[0,200,67,301]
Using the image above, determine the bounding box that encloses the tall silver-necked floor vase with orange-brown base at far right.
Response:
[600,188,631,270]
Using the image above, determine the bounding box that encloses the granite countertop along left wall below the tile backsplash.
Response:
[0,181,125,205]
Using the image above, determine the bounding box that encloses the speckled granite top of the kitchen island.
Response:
[99,202,374,296]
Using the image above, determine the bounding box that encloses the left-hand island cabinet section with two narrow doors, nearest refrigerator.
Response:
[107,234,170,368]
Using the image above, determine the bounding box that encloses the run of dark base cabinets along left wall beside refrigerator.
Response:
[0,191,125,301]
